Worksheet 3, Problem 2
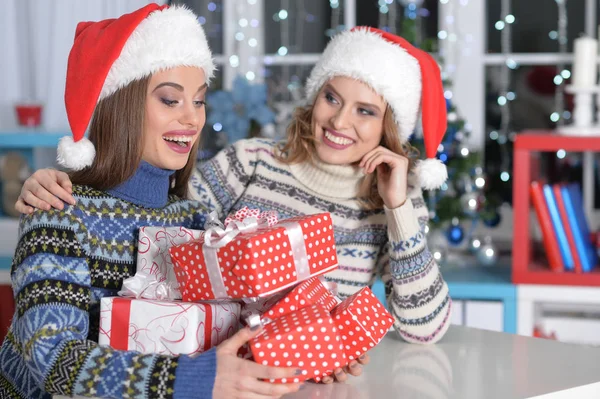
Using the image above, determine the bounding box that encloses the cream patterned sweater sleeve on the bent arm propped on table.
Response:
[379,180,452,343]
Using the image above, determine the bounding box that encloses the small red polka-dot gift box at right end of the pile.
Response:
[331,287,394,361]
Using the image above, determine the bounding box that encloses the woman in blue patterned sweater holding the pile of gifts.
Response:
[0,4,299,399]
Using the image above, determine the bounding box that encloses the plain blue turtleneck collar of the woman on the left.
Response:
[108,161,175,208]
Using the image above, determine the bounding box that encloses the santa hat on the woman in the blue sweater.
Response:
[57,4,215,170]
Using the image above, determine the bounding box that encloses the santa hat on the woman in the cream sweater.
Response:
[306,26,448,189]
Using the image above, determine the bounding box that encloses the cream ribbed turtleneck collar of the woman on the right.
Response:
[290,159,365,199]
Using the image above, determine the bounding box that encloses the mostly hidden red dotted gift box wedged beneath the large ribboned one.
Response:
[262,277,339,320]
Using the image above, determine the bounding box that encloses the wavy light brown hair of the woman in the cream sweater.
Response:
[275,101,418,210]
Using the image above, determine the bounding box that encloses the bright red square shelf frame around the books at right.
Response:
[512,130,600,286]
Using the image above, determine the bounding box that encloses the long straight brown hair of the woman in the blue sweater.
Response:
[70,77,200,198]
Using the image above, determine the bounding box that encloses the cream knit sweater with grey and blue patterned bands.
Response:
[190,139,451,343]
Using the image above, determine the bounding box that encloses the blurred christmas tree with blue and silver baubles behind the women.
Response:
[396,0,502,265]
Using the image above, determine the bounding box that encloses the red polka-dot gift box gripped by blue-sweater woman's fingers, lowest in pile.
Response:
[250,304,348,383]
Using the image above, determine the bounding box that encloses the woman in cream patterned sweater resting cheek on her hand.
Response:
[17,27,451,381]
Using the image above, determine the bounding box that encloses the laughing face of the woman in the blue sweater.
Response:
[142,67,207,170]
